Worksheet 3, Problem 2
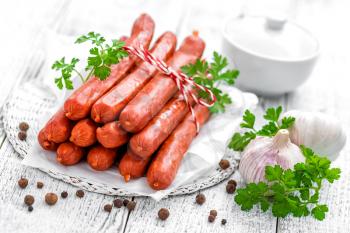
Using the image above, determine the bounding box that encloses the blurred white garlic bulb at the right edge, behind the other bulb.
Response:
[283,110,346,160]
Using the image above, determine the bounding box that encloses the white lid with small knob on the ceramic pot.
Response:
[224,15,319,60]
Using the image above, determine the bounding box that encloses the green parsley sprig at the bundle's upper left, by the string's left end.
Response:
[52,32,128,89]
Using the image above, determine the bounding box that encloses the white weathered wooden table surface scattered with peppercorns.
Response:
[0,0,350,233]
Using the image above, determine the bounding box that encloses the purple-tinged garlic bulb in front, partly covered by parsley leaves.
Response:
[239,129,305,182]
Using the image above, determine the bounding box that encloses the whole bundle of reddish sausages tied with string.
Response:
[38,14,210,190]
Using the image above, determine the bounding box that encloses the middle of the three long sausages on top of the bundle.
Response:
[91,32,176,123]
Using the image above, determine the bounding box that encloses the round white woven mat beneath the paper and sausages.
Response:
[0,82,243,196]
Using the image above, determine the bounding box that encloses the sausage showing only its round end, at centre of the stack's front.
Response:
[96,121,129,148]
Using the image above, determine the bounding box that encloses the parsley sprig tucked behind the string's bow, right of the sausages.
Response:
[181,52,239,113]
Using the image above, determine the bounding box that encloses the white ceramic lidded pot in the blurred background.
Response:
[223,16,320,96]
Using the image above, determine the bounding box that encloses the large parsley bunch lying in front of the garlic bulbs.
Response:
[235,146,341,220]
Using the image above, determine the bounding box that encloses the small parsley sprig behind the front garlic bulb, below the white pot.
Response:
[228,106,295,151]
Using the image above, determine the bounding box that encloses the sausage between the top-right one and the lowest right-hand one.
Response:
[129,94,193,159]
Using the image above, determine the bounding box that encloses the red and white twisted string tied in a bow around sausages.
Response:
[123,45,216,133]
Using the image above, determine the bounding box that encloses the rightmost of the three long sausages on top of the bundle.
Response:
[119,34,205,133]
